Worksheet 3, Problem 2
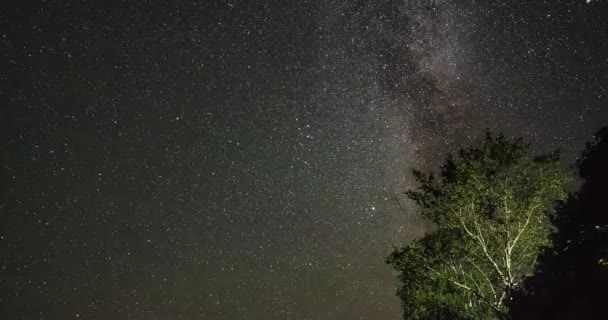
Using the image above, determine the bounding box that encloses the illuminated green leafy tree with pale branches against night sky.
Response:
[387,133,569,319]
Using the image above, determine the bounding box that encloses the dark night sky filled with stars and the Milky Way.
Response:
[0,0,608,320]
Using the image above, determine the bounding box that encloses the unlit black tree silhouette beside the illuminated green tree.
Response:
[510,127,608,319]
